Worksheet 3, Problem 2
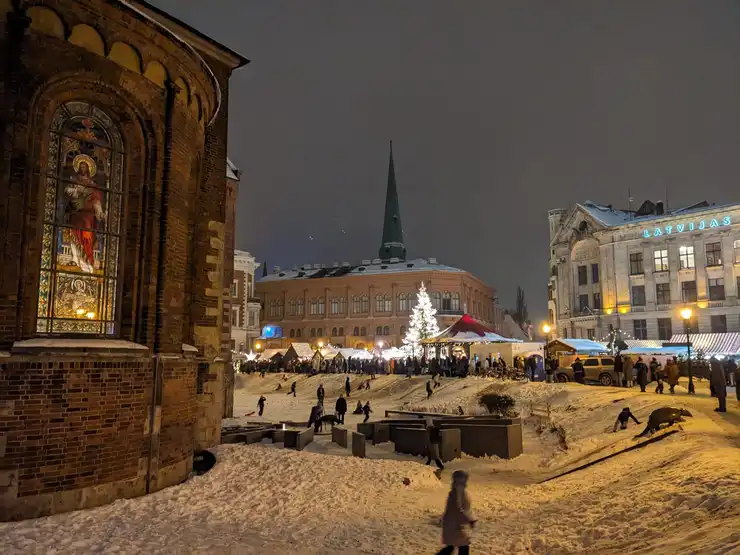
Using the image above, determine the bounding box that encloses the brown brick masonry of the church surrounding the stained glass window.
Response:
[0,0,243,520]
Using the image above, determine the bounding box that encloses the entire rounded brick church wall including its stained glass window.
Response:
[0,0,247,519]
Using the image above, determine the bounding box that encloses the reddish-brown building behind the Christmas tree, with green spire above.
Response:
[257,143,503,348]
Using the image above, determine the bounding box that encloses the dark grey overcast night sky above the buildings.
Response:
[150,0,740,319]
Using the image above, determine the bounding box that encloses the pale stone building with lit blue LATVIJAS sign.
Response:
[548,201,740,341]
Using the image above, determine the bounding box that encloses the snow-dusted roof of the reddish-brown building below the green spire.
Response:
[259,258,465,282]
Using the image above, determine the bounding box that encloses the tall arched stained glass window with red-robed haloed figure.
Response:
[36,102,125,335]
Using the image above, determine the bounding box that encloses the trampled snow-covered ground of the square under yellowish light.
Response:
[0,375,740,555]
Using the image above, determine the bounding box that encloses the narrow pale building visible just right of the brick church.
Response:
[236,250,260,352]
